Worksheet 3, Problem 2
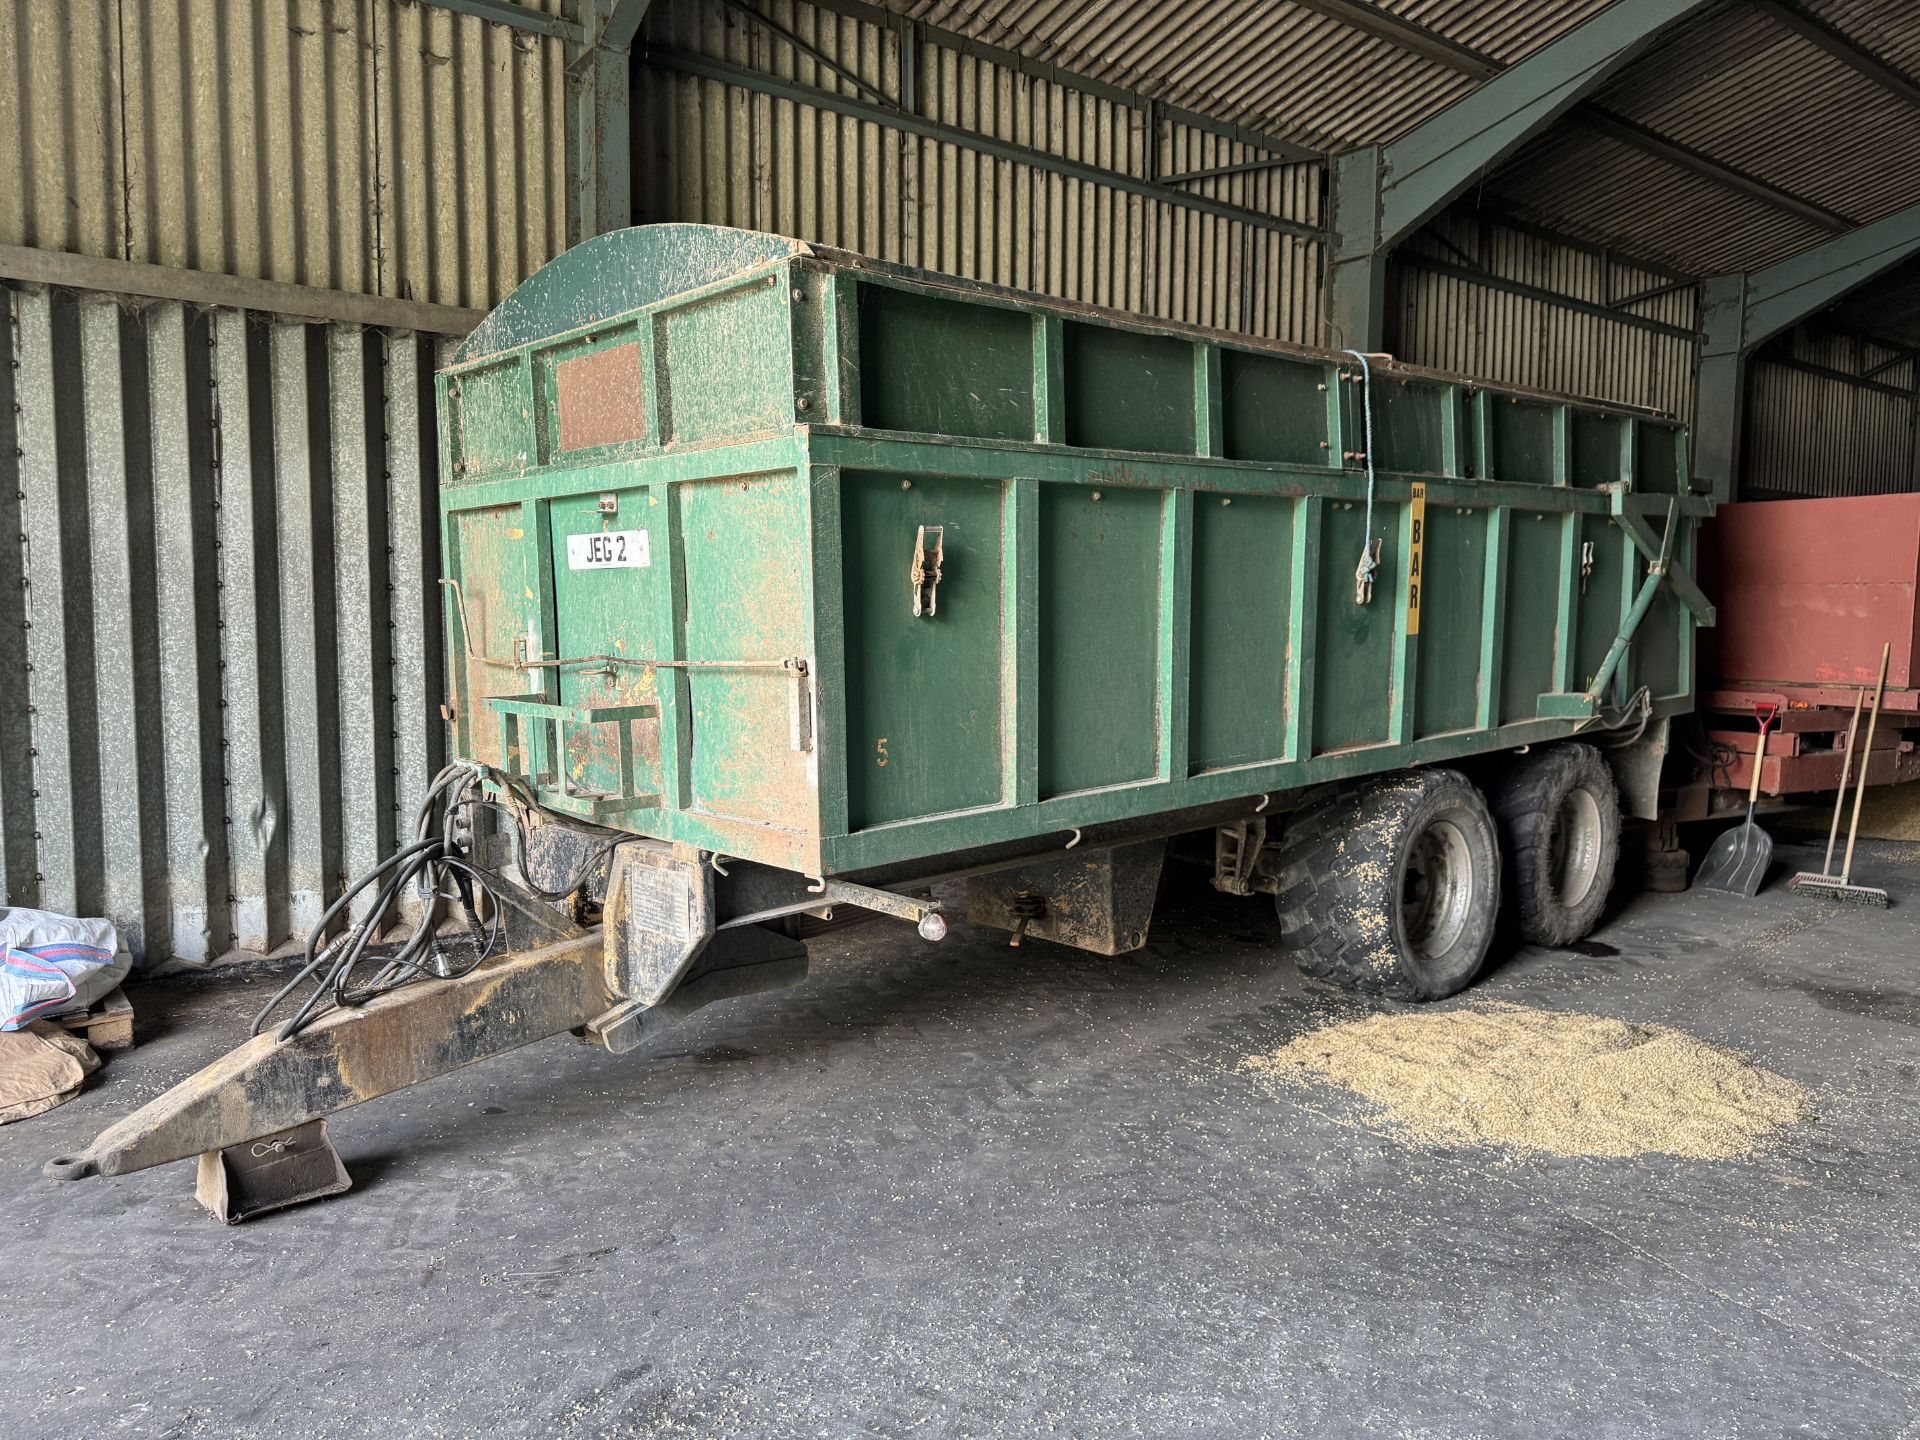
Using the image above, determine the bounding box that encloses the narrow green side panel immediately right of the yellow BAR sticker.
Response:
[1413,505,1488,735]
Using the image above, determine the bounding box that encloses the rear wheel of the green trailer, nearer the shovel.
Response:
[1494,743,1620,945]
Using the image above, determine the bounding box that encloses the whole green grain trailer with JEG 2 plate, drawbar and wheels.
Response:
[61,225,1713,1198]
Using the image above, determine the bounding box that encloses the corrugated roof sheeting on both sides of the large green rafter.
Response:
[887,0,1920,293]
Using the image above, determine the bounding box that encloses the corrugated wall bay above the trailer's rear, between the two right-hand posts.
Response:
[1388,213,1695,419]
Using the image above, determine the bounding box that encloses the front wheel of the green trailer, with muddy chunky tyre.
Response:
[1275,770,1500,1000]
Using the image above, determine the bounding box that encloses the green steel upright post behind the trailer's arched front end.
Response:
[566,0,651,244]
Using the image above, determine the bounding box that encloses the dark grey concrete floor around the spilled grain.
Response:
[0,845,1920,1438]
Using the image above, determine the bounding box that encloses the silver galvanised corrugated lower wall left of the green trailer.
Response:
[0,286,444,964]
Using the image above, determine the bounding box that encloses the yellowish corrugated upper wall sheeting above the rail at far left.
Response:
[0,0,566,309]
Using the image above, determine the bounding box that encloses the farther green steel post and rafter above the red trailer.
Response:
[1693,205,1920,501]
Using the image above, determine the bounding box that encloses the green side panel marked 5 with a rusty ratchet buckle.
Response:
[841,474,1004,829]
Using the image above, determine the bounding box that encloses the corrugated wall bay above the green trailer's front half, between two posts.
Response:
[636,0,1321,344]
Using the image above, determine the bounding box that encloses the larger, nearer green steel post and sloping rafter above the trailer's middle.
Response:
[1329,0,1715,349]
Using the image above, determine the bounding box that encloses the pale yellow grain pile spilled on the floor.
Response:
[1244,1002,1809,1160]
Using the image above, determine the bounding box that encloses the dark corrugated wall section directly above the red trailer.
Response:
[1741,326,1920,499]
